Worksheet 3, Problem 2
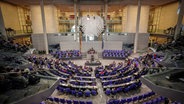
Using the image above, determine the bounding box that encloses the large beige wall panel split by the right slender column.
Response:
[123,5,150,33]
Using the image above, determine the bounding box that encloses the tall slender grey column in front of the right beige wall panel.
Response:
[134,0,141,53]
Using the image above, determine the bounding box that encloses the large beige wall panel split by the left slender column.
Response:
[31,5,58,34]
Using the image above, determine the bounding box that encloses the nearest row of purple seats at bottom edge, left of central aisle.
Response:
[40,97,93,104]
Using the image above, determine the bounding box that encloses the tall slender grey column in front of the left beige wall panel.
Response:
[40,0,49,54]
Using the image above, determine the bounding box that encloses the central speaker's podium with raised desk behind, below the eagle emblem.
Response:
[85,48,101,66]
